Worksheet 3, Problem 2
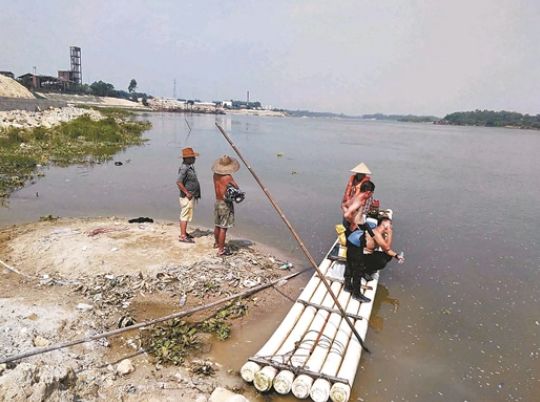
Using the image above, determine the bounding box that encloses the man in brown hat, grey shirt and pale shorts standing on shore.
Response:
[176,147,201,243]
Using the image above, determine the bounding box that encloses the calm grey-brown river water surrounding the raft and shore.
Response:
[0,114,540,401]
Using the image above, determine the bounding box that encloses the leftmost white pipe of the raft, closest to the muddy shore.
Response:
[240,260,331,382]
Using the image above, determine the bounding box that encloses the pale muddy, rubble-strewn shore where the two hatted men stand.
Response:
[0,218,298,401]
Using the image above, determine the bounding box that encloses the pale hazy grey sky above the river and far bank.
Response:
[0,0,540,115]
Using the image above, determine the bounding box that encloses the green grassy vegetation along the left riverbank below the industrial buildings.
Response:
[0,109,150,198]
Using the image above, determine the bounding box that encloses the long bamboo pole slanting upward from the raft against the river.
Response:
[216,122,371,353]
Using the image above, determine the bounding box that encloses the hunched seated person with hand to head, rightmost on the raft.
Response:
[362,216,405,281]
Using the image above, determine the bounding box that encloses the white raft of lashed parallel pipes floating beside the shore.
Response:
[240,211,391,402]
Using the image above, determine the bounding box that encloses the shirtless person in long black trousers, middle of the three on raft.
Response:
[343,181,375,303]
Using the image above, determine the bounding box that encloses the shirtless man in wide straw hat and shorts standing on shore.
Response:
[212,155,240,256]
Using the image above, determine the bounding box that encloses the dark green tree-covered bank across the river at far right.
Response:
[437,110,540,130]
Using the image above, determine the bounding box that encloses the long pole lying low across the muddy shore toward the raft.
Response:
[0,268,309,364]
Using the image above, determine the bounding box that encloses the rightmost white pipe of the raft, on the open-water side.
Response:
[330,280,377,402]
